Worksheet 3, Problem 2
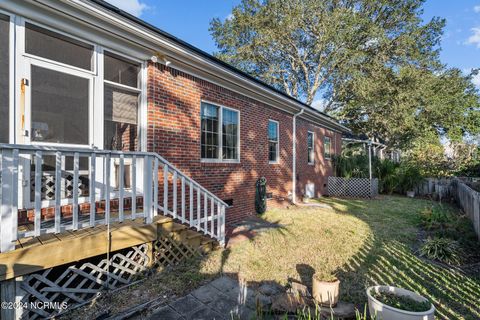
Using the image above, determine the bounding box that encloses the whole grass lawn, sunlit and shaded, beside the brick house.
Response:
[203,196,480,319]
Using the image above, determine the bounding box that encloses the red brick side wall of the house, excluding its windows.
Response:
[147,64,340,224]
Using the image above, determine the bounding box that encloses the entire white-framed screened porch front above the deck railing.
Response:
[12,15,146,151]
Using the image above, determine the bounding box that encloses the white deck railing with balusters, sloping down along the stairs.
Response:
[0,144,227,252]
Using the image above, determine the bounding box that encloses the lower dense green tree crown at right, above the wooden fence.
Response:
[336,66,480,150]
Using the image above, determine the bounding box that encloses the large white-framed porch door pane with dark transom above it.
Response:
[25,22,94,145]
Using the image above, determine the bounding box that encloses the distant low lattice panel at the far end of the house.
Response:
[327,177,378,198]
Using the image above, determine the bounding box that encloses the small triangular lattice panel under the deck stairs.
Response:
[153,235,200,267]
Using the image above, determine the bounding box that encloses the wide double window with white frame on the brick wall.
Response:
[201,102,240,161]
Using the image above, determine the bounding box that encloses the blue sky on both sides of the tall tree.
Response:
[108,0,480,87]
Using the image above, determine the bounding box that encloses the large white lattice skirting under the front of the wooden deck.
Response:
[21,244,149,320]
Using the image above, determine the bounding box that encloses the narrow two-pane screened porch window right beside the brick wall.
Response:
[104,51,141,151]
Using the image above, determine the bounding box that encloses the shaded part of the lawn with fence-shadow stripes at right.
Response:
[322,197,480,319]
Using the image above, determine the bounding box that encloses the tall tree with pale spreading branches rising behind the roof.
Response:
[210,0,444,108]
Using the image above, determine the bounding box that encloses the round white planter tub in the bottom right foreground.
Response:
[367,286,435,320]
